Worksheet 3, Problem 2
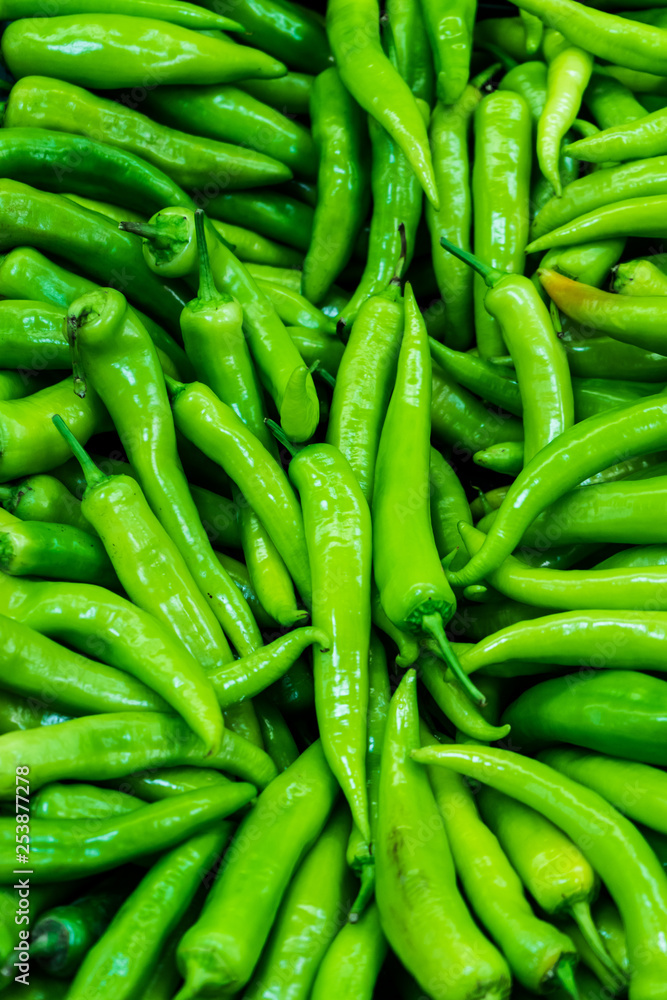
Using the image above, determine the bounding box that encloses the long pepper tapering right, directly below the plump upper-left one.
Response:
[5,77,292,196]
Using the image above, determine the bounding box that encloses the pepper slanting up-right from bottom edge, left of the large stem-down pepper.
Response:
[70,828,233,1000]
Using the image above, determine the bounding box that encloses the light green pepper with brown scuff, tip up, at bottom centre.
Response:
[375,670,510,1000]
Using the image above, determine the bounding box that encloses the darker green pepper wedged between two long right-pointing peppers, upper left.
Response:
[143,86,317,177]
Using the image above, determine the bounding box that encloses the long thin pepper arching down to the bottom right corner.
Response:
[413,746,667,1000]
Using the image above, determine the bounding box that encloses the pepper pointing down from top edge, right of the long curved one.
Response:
[420,0,477,103]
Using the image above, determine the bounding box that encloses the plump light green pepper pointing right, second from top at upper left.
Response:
[2,12,286,90]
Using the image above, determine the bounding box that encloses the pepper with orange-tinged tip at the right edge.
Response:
[539,268,667,355]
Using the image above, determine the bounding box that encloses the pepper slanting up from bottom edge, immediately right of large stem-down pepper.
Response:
[243,806,351,1000]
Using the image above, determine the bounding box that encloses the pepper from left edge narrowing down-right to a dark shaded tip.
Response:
[0,180,185,332]
